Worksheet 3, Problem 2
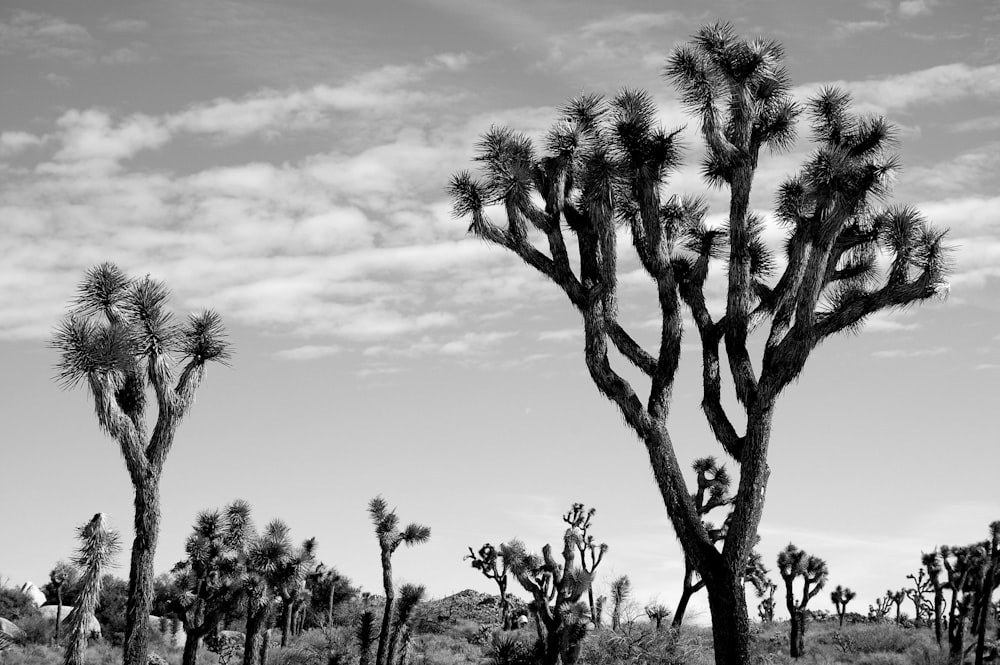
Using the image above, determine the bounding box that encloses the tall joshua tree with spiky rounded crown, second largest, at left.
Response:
[52,263,230,665]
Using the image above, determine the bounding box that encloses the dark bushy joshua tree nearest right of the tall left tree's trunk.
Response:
[169,499,253,665]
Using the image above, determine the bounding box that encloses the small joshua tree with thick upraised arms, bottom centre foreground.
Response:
[501,525,594,665]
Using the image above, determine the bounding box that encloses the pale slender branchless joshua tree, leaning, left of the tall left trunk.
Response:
[64,513,121,665]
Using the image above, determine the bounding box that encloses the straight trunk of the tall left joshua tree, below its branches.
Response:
[122,471,160,665]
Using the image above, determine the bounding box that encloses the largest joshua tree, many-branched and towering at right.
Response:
[449,24,946,665]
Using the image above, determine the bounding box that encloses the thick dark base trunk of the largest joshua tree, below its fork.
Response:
[703,569,751,665]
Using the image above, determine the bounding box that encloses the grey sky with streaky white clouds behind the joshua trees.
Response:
[0,0,1000,622]
